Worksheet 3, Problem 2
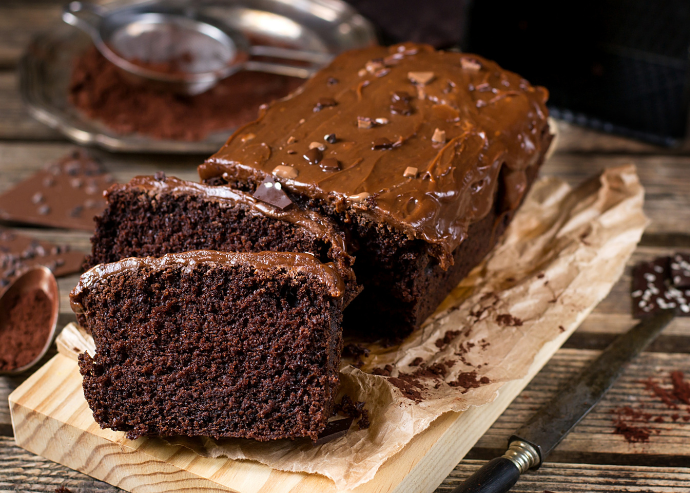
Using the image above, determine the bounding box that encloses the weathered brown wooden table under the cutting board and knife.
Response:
[0,0,690,493]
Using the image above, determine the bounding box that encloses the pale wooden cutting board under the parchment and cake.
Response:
[9,322,574,493]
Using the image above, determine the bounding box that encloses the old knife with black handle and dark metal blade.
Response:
[452,310,674,493]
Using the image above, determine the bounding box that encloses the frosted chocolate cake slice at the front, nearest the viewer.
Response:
[70,251,345,440]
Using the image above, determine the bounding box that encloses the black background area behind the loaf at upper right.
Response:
[348,0,690,146]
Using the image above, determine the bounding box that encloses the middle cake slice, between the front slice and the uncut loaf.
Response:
[85,173,361,303]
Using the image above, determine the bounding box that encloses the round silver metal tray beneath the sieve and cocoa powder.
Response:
[19,0,376,154]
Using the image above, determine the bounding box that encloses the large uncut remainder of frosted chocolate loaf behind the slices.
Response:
[199,44,552,336]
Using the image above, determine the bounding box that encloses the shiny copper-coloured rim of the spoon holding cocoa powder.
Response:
[0,265,60,375]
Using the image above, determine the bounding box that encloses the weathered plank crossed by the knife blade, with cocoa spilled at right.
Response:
[470,349,690,465]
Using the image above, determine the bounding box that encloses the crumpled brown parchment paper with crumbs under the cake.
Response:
[59,165,647,490]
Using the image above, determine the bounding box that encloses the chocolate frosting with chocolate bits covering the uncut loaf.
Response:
[199,43,550,263]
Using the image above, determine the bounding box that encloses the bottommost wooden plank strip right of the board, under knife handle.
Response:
[435,460,690,493]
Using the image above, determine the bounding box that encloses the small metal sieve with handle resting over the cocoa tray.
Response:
[62,1,333,95]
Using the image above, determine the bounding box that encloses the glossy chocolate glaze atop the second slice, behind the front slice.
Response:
[116,176,354,265]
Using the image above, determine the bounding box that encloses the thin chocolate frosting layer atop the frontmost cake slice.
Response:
[70,250,345,315]
